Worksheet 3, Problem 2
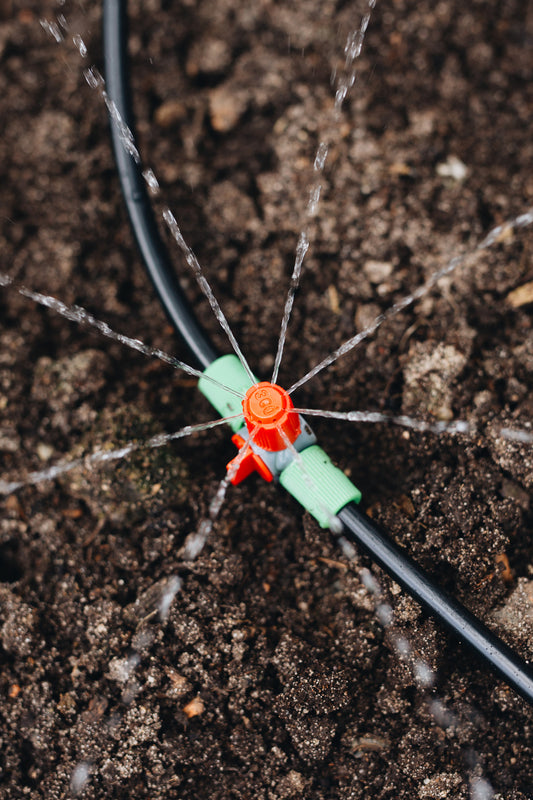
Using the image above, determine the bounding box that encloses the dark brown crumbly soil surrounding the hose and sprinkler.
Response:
[0,0,533,800]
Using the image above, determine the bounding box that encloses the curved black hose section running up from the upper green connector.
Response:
[103,0,219,369]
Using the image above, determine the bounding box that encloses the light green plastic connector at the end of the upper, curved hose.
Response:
[198,354,259,433]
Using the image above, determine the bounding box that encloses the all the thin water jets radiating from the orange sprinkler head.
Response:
[0,0,533,800]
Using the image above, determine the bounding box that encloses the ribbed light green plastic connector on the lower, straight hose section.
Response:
[279,444,361,528]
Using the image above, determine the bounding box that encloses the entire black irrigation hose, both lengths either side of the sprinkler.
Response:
[103,0,533,705]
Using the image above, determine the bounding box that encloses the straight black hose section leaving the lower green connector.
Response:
[337,503,533,705]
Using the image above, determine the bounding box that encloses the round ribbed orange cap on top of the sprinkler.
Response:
[242,381,301,452]
